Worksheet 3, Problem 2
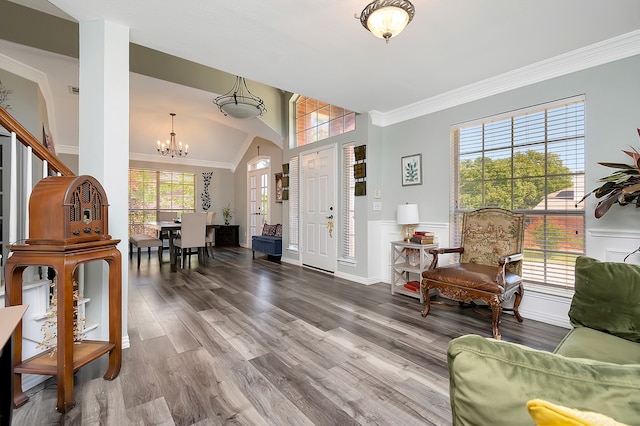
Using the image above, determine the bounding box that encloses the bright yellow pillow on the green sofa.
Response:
[527,399,626,426]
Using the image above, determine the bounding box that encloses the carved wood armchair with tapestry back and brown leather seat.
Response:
[421,208,524,339]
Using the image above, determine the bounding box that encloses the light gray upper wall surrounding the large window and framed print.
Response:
[381,56,640,240]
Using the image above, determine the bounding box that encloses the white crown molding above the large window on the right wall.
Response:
[369,30,640,127]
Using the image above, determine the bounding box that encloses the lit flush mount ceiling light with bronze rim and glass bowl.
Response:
[360,0,416,43]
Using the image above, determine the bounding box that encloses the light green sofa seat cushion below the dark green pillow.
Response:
[554,327,640,364]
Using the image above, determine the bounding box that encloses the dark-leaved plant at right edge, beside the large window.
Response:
[576,128,640,219]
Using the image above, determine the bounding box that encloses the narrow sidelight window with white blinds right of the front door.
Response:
[340,145,356,261]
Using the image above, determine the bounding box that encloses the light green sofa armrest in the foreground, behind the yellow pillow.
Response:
[447,335,640,426]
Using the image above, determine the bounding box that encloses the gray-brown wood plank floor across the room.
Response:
[12,248,566,426]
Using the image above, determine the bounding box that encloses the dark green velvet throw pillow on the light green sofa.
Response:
[569,256,640,342]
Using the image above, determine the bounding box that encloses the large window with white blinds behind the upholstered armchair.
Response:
[451,96,585,288]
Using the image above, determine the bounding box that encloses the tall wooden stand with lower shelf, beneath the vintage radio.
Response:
[5,239,122,413]
